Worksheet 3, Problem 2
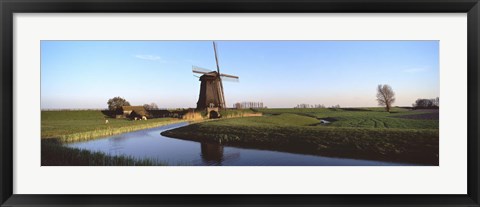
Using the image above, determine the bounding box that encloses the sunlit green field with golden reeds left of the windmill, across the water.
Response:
[41,110,184,142]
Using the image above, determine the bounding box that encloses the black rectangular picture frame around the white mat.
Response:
[0,0,480,206]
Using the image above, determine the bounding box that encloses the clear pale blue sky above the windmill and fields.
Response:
[41,41,440,109]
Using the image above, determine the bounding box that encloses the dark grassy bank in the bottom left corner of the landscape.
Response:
[41,139,168,166]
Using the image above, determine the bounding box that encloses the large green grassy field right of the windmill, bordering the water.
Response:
[162,108,438,165]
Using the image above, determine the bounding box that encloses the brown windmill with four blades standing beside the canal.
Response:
[192,42,238,109]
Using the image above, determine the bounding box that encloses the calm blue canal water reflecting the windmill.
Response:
[63,123,406,166]
